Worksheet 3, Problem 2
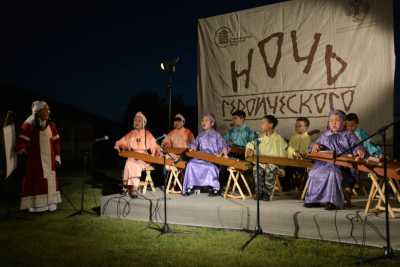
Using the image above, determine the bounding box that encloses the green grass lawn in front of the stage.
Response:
[0,171,400,267]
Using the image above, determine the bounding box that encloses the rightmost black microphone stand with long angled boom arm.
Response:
[337,120,400,264]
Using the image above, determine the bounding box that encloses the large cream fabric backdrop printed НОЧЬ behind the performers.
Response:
[198,0,395,142]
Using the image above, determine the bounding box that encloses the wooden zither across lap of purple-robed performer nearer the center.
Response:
[164,148,251,171]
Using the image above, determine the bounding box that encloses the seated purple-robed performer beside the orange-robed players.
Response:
[183,113,228,196]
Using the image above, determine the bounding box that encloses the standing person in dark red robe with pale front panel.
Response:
[16,101,61,212]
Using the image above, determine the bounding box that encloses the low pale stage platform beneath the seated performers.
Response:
[101,189,400,250]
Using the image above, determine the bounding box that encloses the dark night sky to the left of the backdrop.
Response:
[4,0,398,120]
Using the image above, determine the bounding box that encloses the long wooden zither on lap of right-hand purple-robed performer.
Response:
[306,151,400,180]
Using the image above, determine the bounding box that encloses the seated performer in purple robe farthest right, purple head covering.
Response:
[304,110,365,209]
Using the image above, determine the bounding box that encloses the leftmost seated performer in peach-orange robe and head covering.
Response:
[114,112,160,198]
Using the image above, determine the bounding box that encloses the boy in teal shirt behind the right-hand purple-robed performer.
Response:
[345,113,383,157]
